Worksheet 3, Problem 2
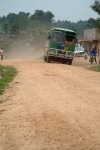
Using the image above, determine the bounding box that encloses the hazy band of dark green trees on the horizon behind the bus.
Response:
[0,10,96,35]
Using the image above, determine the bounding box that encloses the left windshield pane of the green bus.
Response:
[52,33,64,43]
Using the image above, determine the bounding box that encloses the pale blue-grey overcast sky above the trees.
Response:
[0,0,98,22]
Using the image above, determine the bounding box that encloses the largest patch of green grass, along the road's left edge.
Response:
[0,65,18,95]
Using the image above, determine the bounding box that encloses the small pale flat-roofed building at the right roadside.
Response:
[77,28,100,52]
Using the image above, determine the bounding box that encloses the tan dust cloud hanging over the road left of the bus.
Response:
[5,40,44,59]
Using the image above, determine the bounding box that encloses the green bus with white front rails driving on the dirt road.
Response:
[44,28,76,65]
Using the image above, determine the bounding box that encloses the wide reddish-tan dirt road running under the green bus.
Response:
[0,59,100,150]
